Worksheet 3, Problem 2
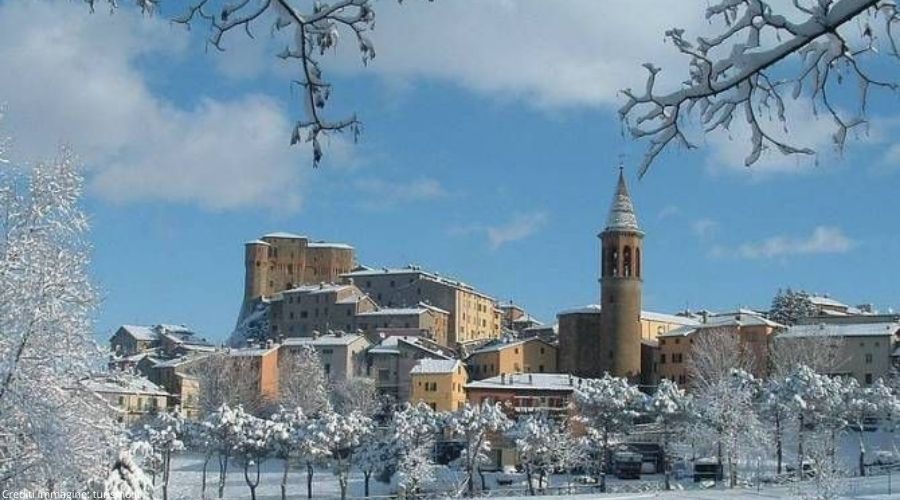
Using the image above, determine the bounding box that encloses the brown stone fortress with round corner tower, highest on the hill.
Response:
[244,233,356,304]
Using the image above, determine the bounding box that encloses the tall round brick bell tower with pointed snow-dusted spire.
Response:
[596,167,644,380]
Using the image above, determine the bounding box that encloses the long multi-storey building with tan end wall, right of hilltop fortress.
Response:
[343,266,502,348]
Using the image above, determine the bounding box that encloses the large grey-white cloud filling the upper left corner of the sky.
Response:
[0,2,326,209]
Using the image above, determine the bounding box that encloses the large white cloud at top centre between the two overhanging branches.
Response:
[330,0,706,108]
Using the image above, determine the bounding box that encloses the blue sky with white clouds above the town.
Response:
[0,0,900,339]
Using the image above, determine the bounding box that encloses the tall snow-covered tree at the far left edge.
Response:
[0,143,120,489]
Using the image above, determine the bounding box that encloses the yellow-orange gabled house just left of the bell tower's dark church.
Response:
[466,338,557,380]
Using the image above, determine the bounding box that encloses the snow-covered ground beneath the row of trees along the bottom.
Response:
[169,432,900,500]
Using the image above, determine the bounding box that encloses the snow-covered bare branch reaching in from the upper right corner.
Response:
[619,0,900,175]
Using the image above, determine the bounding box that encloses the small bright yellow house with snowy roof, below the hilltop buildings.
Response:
[410,358,469,411]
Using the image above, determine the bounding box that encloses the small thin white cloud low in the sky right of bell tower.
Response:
[713,226,858,259]
